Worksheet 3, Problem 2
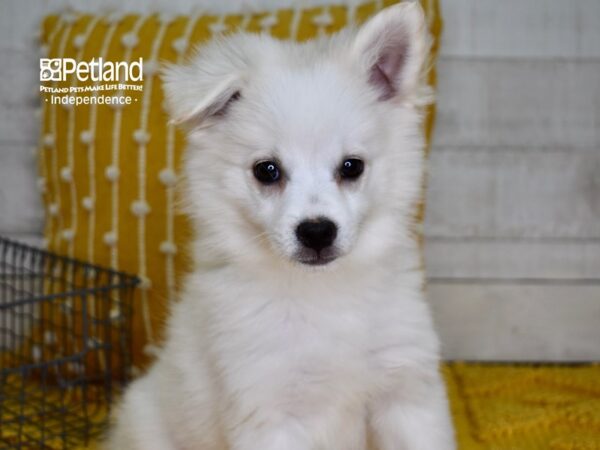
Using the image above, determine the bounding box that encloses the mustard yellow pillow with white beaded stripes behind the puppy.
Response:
[39,0,441,367]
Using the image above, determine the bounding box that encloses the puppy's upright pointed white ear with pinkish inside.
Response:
[352,1,428,100]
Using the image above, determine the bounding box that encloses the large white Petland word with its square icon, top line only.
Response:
[40,58,144,82]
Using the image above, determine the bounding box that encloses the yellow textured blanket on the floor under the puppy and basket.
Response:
[0,363,600,450]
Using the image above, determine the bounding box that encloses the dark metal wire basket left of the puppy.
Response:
[0,237,138,449]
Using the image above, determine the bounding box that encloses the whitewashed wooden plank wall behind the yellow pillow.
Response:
[0,0,600,360]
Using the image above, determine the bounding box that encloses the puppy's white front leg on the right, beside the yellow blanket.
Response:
[370,378,456,450]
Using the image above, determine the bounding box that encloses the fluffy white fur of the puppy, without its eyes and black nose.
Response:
[106,3,454,450]
